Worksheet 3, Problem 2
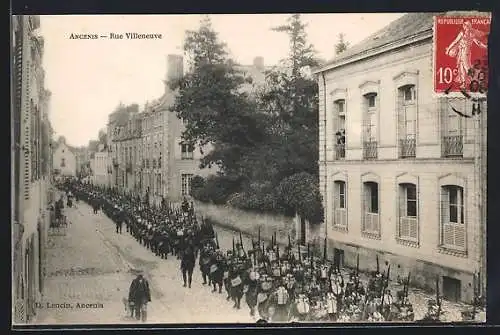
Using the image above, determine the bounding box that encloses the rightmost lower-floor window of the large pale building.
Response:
[441,185,466,250]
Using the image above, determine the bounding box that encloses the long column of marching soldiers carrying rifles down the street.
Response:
[56,178,482,322]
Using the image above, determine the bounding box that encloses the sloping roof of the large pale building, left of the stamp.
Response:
[314,13,440,73]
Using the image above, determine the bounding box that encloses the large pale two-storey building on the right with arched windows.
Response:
[317,13,485,302]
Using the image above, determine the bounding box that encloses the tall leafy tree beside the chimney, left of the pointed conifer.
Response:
[169,17,264,174]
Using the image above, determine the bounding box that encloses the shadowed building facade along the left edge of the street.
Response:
[11,15,53,324]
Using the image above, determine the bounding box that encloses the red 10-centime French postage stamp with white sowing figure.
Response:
[434,16,491,95]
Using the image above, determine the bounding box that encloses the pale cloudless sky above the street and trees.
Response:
[40,13,402,146]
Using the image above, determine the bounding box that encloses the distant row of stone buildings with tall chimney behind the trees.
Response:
[91,55,269,203]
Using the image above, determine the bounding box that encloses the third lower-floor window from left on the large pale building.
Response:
[398,183,418,241]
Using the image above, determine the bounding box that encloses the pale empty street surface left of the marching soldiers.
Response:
[36,202,255,324]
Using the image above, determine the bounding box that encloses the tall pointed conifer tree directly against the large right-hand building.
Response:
[259,14,318,181]
